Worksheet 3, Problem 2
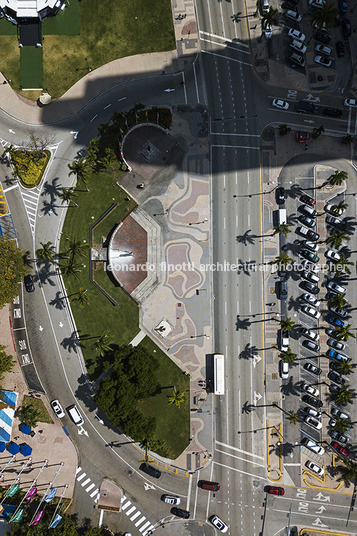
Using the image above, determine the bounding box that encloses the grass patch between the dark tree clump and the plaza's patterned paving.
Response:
[139,337,190,460]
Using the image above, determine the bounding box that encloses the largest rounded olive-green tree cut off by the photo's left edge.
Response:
[0,236,29,308]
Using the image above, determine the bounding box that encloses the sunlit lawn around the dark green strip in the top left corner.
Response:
[0,0,176,99]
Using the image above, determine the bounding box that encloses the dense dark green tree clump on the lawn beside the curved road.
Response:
[95,346,160,441]
